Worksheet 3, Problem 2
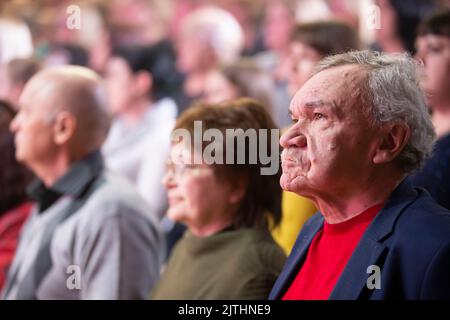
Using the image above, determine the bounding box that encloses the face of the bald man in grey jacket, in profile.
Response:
[11,81,57,167]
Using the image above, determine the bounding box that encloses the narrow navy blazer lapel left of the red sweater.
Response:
[269,213,324,300]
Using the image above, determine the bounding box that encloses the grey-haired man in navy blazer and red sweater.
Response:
[270,51,450,300]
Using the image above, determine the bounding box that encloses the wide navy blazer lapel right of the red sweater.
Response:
[329,178,418,300]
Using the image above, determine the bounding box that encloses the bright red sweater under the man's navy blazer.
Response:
[283,204,383,300]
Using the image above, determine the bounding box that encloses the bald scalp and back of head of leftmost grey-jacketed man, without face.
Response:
[21,66,110,153]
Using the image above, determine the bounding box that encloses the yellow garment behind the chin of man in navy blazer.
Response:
[272,191,317,255]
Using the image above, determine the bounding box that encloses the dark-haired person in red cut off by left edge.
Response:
[0,102,32,290]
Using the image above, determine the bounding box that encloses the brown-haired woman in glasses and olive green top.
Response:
[152,99,285,299]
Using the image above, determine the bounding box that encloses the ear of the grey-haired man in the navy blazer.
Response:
[373,122,411,164]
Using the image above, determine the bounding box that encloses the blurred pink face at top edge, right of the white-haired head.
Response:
[264,2,294,50]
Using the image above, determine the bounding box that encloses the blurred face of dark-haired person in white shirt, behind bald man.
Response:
[105,57,135,115]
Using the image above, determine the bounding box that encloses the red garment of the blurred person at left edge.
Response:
[0,202,32,291]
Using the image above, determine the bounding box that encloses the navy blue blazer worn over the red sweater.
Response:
[269,179,450,300]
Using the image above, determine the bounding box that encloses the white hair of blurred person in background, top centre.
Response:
[182,7,244,64]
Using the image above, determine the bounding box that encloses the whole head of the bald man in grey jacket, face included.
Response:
[11,66,110,172]
